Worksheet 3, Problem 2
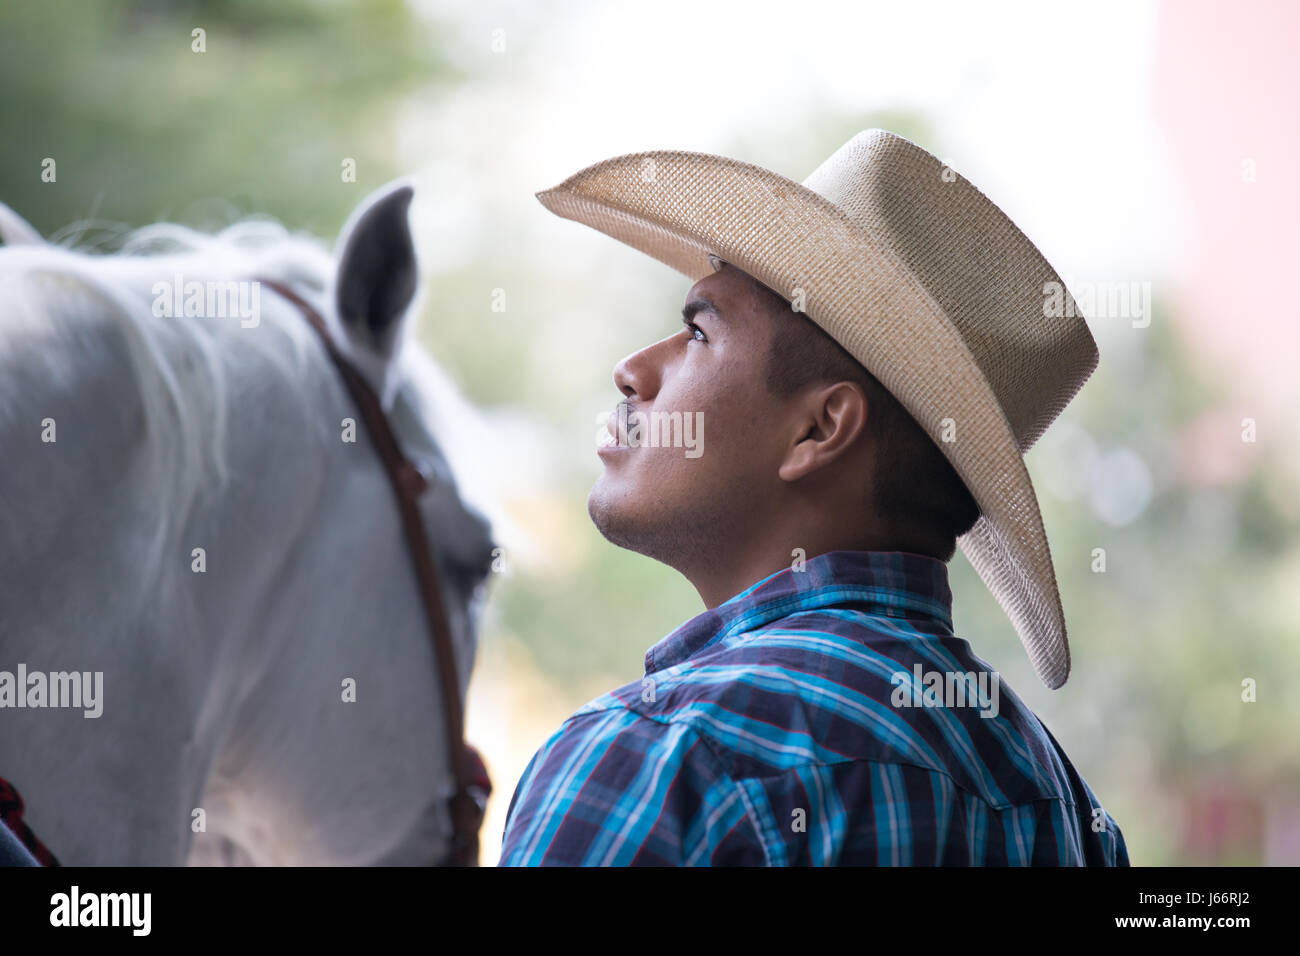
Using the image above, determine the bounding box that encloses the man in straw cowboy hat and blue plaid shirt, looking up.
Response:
[501,130,1128,866]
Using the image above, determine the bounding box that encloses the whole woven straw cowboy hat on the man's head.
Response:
[537,129,1097,688]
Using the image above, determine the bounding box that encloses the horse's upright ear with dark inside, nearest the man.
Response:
[334,179,419,359]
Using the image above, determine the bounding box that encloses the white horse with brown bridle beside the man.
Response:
[0,182,494,865]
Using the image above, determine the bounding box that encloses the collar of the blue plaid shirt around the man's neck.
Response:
[645,551,953,674]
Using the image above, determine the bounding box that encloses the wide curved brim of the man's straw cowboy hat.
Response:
[537,151,1070,689]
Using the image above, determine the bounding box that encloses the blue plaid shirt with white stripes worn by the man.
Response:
[499,551,1128,866]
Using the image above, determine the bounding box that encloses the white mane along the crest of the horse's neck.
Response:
[0,220,334,574]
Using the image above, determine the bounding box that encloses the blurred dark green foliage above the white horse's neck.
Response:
[0,0,443,235]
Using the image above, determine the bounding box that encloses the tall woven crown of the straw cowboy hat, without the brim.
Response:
[802,129,1097,454]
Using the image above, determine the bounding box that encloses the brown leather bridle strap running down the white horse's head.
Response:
[256,278,486,865]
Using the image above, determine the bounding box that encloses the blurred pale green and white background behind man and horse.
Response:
[0,0,1300,865]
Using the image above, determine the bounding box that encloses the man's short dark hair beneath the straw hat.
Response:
[761,291,980,562]
